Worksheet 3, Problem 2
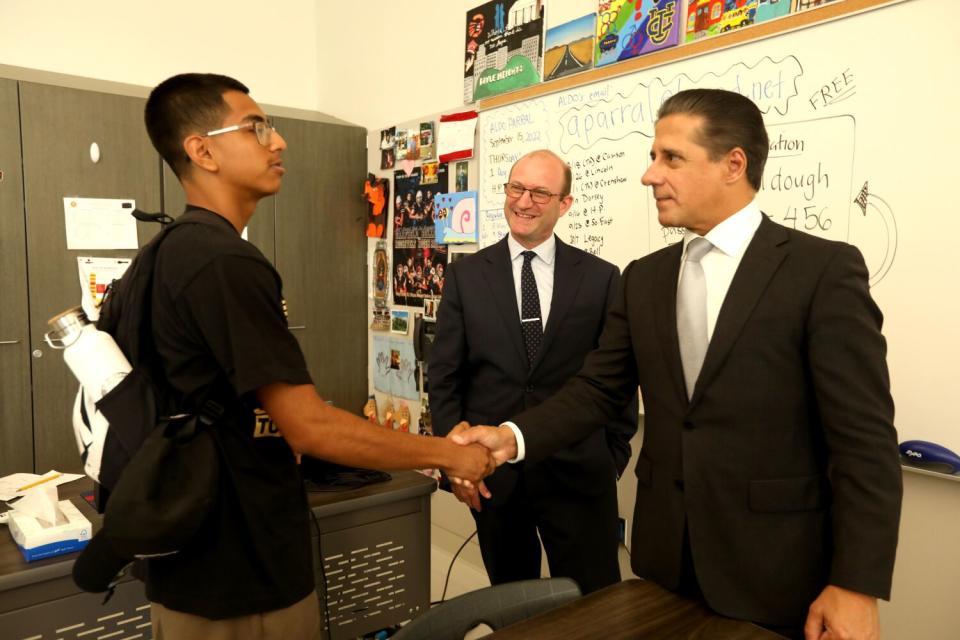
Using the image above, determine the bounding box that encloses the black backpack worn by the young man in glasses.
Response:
[73,212,223,598]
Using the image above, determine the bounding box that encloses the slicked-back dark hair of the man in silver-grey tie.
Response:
[657,89,770,191]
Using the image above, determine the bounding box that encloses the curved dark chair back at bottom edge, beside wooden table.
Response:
[393,578,580,640]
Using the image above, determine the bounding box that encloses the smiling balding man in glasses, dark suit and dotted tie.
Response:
[428,150,637,592]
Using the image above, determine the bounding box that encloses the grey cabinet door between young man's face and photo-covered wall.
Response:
[273,118,369,413]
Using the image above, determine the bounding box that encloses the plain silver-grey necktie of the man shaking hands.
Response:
[677,238,713,399]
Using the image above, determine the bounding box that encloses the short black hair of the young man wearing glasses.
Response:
[143,73,250,178]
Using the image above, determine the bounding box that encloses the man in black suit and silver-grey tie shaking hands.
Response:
[455,89,902,640]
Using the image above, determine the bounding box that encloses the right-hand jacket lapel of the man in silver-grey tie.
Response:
[691,216,789,402]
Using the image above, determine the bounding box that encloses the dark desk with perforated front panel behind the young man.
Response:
[0,471,437,640]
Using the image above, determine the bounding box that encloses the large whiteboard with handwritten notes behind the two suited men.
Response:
[479,0,960,453]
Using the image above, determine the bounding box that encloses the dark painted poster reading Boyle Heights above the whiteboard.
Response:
[463,0,543,104]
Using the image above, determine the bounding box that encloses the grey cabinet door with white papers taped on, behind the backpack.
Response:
[20,82,160,473]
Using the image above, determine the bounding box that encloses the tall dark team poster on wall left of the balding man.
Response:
[393,164,447,307]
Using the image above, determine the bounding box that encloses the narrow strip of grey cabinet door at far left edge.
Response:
[0,80,33,476]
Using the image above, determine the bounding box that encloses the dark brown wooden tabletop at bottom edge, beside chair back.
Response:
[487,579,781,640]
